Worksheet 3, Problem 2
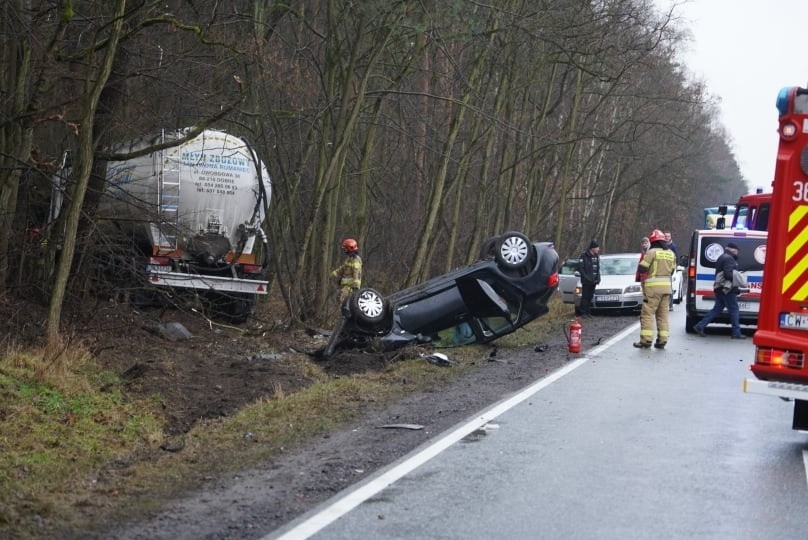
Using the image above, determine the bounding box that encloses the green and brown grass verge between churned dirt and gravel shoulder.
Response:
[0,296,572,537]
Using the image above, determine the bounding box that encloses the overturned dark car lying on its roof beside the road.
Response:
[323,232,558,357]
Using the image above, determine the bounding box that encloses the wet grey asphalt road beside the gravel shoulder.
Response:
[272,308,808,540]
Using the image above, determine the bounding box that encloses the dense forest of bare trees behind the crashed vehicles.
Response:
[0,0,752,340]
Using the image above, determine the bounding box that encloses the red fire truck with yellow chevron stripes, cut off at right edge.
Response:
[744,87,808,430]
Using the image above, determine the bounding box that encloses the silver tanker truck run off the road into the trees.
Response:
[51,128,271,322]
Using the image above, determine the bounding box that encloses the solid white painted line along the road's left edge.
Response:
[264,322,640,540]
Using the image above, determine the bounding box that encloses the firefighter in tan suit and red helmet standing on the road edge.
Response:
[634,229,676,349]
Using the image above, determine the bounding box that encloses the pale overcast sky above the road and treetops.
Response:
[654,0,808,191]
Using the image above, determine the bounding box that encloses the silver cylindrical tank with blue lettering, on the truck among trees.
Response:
[97,129,271,258]
